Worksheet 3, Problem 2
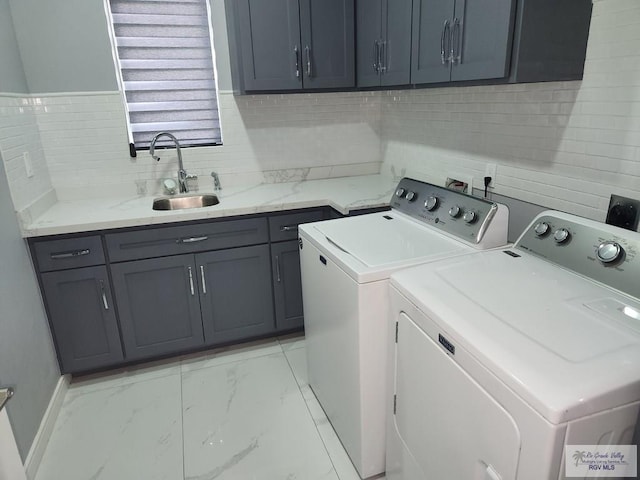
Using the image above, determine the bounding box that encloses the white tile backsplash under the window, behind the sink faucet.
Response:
[38,92,380,199]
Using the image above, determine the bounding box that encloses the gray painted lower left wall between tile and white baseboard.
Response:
[0,151,60,460]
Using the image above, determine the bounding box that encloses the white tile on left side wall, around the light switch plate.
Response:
[0,93,55,211]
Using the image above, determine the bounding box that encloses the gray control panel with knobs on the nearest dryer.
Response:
[514,212,640,297]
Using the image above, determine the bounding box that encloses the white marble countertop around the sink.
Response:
[22,175,397,237]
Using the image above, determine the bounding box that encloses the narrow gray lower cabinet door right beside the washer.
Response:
[271,240,304,330]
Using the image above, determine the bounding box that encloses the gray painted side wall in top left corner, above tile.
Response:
[0,0,27,93]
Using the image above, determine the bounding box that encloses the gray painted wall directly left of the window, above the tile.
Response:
[7,0,118,93]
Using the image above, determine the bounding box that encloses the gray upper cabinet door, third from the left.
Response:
[356,0,380,87]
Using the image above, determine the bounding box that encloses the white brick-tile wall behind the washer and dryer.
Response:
[381,0,640,220]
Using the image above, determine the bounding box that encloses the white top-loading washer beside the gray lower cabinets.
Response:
[299,178,508,478]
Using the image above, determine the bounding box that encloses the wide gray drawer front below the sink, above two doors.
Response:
[105,218,269,262]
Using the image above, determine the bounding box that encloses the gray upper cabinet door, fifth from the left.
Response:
[411,0,456,83]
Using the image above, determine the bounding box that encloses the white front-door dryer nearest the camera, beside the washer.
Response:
[386,212,640,480]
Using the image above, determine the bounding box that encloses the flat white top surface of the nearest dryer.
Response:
[391,251,640,424]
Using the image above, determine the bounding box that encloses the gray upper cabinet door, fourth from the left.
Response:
[380,0,413,85]
